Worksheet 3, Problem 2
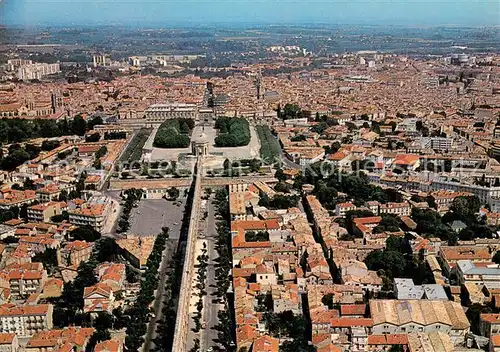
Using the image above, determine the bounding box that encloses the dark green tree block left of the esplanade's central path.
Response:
[153,119,194,148]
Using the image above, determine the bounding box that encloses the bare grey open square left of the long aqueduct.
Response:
[128,198,186,239]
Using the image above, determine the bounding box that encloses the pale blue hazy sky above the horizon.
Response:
[0,0,500,26]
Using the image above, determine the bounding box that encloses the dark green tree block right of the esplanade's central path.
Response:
[215,117,250,147]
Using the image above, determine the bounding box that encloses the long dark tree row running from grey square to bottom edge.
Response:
[125,227,169,351]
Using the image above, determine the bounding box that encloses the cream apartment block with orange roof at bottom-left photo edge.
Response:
[0,304,54,338]
